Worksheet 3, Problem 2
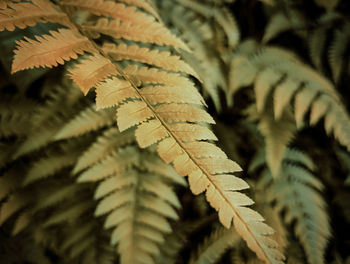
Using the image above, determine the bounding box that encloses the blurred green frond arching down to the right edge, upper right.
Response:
[228,41,350,152]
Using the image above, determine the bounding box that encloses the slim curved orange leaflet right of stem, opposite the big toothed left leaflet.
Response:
[102,43,198,77]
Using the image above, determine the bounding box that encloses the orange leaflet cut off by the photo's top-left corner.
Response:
[0,0,70,31]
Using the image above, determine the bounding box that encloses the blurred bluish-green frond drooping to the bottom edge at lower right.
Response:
[251,150,331,264]
